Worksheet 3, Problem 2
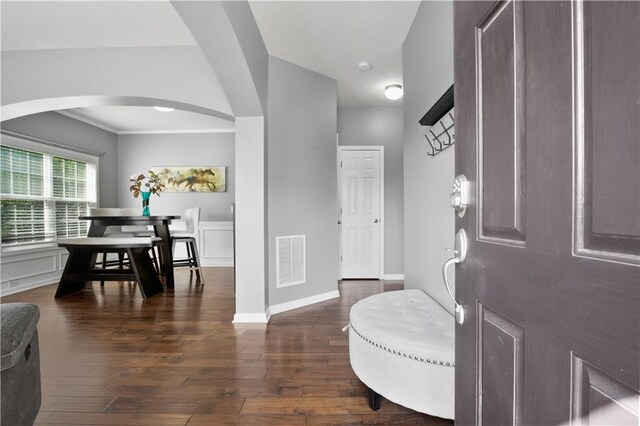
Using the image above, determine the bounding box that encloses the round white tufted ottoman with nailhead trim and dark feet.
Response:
[349,290,455,419]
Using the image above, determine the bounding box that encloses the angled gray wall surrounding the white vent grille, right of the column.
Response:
[267,57,338,305]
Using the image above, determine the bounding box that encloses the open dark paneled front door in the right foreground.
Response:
[454,2,640,425]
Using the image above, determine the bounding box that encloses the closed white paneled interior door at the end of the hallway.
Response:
[339,147,382,278]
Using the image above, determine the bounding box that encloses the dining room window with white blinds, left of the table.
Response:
[0,135,98,246]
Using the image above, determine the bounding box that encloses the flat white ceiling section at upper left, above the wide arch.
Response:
[1,1,196,50]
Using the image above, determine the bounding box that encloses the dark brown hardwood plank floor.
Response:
[1,268,451,426]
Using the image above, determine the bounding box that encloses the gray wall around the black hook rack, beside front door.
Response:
[402,1,455,312]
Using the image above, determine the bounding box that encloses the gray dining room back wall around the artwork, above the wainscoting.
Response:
[118,133,235,221]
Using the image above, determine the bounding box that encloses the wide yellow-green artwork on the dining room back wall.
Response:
[151,166,227,192]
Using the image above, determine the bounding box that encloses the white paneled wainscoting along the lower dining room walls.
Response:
[0,222,233,297]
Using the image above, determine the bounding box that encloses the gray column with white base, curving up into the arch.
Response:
[171,0,269,322]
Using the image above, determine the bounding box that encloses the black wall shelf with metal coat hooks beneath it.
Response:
[420,85,456,157]
